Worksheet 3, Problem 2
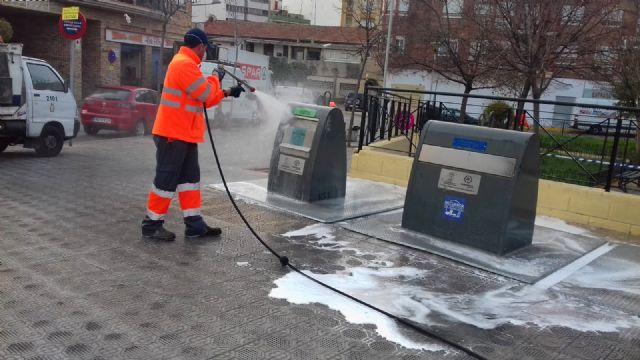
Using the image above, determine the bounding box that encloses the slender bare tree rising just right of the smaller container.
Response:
[348,0,383,143]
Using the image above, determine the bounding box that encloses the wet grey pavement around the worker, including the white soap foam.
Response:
[0,129,640,360]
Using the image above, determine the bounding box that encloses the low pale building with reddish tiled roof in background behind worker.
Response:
[204,21,362,98]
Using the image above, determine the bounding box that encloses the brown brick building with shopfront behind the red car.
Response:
[0,0,191,101]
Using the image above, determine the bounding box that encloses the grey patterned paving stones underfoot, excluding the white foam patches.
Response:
[0,132,640,360]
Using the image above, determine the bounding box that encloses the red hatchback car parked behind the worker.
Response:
[80,86,158,136]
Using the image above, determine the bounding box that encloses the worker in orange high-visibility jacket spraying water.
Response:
[142,29,244,241]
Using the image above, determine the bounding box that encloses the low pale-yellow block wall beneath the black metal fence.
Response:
[349,143,640,237]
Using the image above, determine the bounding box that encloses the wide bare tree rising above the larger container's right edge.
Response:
[479,0,622,132]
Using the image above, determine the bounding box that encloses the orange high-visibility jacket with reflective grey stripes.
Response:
[152,46,224,143]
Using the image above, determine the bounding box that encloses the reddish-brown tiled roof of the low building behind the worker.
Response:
[204,20,365,45]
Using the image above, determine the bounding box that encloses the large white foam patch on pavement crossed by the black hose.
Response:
[269,267,640,350]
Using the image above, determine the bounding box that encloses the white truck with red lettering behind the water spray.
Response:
[200,48,273,126]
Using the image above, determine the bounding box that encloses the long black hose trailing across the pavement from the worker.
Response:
[203,104,487,360]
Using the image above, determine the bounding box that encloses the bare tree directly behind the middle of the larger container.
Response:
[394,0,496,123]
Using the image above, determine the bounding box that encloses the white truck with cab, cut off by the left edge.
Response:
[0,44,80,156]
